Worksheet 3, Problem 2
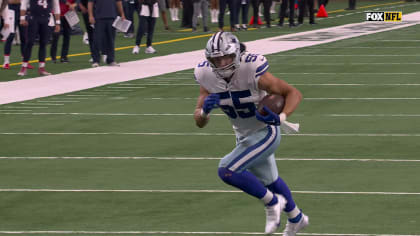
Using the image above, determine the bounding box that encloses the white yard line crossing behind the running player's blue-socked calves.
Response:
[0,188,420,196]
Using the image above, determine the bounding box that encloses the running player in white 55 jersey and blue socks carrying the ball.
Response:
[194,32,309,236]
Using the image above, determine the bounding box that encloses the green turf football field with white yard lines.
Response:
[0,1,420,236]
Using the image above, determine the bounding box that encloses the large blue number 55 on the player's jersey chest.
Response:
[219,90,256,119]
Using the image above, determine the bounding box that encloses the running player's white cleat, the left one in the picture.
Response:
[265,194,287,234]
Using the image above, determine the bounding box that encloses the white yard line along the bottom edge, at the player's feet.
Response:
[0,230,420,236]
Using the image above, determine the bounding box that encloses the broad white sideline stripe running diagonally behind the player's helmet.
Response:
[0,12,420,104]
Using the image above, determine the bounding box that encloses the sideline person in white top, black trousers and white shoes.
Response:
[133,0,159,54]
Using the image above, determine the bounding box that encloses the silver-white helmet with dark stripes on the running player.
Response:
[205,32,241,79]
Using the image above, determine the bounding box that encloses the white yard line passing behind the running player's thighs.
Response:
[0,156,420,163]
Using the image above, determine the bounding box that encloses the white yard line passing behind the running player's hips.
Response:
[0,132,420,137]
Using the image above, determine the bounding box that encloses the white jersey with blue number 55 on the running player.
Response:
[194,52,269,138]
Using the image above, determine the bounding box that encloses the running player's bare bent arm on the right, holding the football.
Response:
[258,72,302,117]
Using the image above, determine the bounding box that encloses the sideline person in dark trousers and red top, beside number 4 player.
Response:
[50,0,76,63]
